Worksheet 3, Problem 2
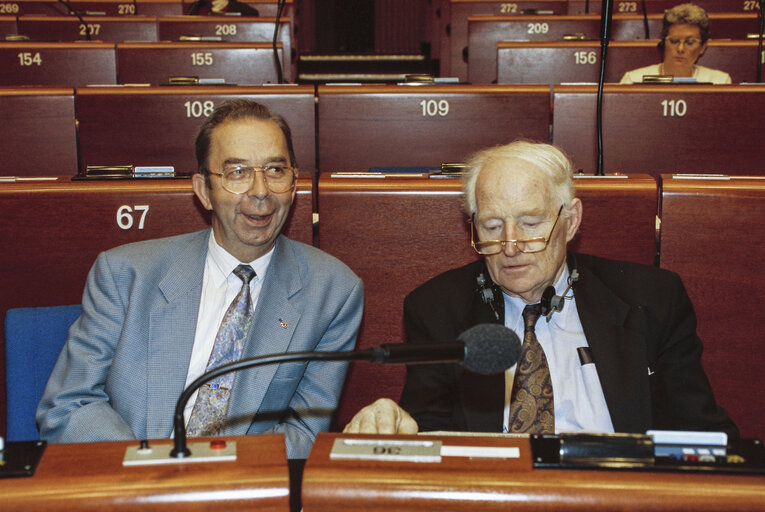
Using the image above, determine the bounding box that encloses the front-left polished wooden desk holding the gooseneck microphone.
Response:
[0,434,289,512]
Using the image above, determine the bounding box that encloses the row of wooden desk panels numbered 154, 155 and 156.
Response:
[0,40,765,87]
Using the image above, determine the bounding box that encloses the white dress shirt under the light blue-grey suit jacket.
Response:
[183,232,274,423]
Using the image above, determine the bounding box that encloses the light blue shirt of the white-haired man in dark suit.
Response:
[502,267,614,433]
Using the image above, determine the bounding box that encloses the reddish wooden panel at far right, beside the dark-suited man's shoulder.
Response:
[661,175,765,439]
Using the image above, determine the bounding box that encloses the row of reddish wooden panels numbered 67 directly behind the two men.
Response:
[0,174,765,438]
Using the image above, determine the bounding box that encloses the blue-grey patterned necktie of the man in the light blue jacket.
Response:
[186,265,255,437]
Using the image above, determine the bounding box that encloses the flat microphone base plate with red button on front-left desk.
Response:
[122,437,236,466]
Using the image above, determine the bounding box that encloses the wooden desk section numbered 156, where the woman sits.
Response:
[497,40,757,84]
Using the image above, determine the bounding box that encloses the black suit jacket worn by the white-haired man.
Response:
[401,254,738,438]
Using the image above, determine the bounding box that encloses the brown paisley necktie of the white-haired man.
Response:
[508,304,555,434]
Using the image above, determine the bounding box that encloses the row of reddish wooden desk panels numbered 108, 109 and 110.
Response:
[0,84,765,176]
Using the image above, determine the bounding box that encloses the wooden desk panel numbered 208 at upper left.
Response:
[159,16,293,82]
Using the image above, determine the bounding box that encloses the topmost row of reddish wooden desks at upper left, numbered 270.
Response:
[0,0,294,17]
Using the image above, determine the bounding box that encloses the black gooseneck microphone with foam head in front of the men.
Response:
[170,324,521,458]
